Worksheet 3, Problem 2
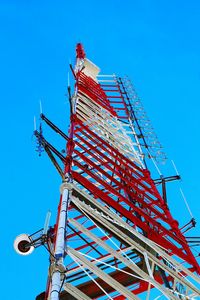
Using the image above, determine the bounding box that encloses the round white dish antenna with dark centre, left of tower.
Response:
[14,233,34,255]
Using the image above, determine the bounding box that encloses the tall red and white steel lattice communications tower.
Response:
[14,44,200,300]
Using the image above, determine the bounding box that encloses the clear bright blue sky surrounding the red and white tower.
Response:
[0,0,200,300]
